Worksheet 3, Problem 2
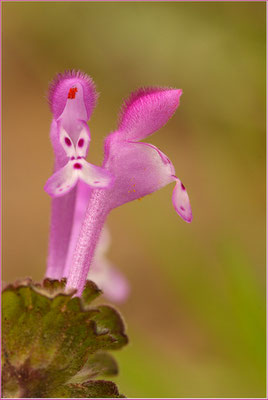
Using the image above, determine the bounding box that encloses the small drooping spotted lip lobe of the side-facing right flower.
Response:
[172,177,193,222]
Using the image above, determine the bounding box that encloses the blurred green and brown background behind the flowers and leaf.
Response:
[2,2,266,398]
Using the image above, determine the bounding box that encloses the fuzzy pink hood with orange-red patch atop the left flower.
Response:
[48,70,97,121]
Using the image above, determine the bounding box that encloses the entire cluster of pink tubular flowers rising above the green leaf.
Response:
[45,71,192,300]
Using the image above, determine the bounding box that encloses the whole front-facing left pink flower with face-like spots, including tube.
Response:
[45,71,112,279]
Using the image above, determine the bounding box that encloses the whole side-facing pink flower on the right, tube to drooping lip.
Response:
[62,83,192,295]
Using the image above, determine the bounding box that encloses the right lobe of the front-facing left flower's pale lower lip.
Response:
[78,159,113,188]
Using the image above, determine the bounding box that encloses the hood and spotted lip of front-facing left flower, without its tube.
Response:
[45,74,113,197]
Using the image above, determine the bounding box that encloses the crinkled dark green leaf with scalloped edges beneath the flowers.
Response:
[2,279,128,398]
